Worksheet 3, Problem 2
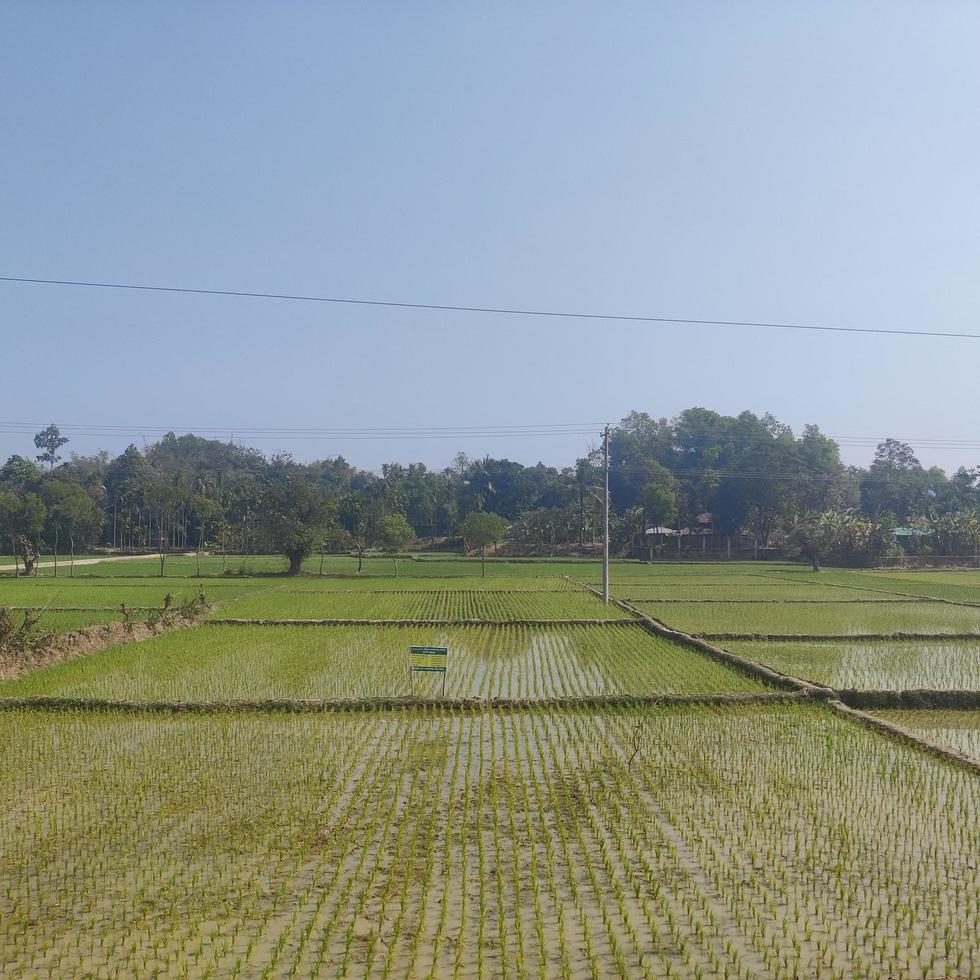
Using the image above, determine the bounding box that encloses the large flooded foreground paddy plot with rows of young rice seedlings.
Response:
[0,706,980,978]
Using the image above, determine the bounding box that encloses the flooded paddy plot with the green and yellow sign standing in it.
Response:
[0,623,766,701]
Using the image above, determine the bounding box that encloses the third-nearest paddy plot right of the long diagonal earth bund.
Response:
[634,602,980,636]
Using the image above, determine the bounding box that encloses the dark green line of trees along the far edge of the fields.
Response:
[0,408,980,573]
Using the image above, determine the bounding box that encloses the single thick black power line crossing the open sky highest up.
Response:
[0,276,980,340]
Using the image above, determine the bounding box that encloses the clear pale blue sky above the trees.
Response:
[0,0,980,478]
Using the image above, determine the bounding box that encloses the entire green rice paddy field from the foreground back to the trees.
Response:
[0,556,980,980]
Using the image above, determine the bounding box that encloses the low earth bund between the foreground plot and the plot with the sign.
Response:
[0,691,812,714]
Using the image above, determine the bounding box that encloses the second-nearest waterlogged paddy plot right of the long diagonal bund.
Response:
[725,639,980,691]
